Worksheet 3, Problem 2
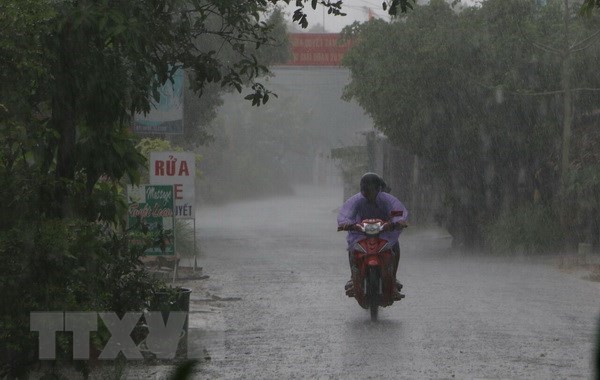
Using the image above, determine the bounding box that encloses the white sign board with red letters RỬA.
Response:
[149,152,196,219]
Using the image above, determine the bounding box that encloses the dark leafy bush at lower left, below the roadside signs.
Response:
[0,219,165,377]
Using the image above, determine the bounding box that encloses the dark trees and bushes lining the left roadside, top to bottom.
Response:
[0,0,360,378]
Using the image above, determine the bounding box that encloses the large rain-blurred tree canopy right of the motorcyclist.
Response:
[344,0,600,245]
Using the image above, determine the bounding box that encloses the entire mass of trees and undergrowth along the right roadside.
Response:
[344,0,600,252]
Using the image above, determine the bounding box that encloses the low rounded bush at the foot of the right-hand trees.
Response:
[485,205,565,253]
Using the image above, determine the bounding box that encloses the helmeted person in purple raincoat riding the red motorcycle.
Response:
[337,173,408,300]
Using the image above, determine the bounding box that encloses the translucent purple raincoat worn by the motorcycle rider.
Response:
[338,191,408,248]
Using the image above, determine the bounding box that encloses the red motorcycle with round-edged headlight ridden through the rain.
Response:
[338,219,406,321]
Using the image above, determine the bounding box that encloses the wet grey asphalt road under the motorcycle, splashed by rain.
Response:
[190,187,600,379]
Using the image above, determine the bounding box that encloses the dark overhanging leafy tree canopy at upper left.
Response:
[0,0,412,221]
